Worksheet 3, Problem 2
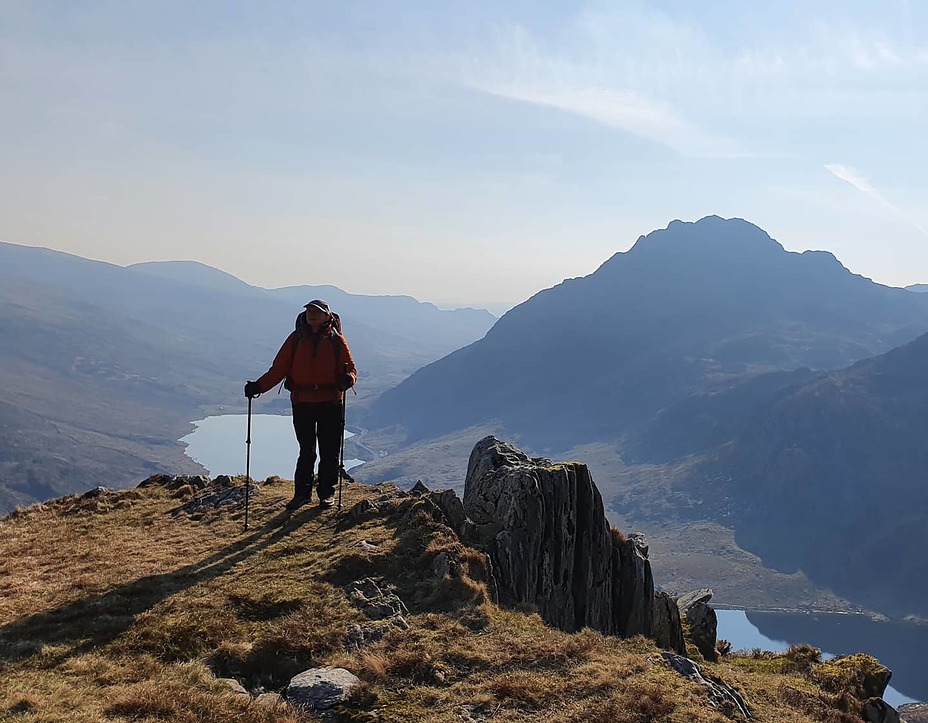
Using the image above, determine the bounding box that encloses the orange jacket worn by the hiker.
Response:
[258,328,358,404]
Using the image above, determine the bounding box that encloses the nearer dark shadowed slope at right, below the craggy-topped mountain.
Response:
[623,335,928,618]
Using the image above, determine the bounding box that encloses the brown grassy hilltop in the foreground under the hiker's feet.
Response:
[0,479,892,723]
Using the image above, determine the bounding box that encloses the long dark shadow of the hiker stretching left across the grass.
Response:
[0,508,319,663]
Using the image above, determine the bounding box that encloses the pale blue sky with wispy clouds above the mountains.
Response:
[0,0,928,310]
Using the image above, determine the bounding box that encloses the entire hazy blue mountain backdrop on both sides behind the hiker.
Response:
[0,216,928,616]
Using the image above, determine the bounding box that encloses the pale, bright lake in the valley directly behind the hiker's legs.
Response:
[180,414,364,480]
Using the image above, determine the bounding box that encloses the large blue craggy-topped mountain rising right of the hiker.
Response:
[369,216,928,449]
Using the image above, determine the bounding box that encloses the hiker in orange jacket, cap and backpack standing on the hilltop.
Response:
[245,299,358,510]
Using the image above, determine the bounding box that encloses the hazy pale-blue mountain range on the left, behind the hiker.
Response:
[0,244,495,511]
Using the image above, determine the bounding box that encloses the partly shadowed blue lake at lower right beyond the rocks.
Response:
[715,610,916,708]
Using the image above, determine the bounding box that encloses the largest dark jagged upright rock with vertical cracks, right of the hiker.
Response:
[463,436,654,635]
